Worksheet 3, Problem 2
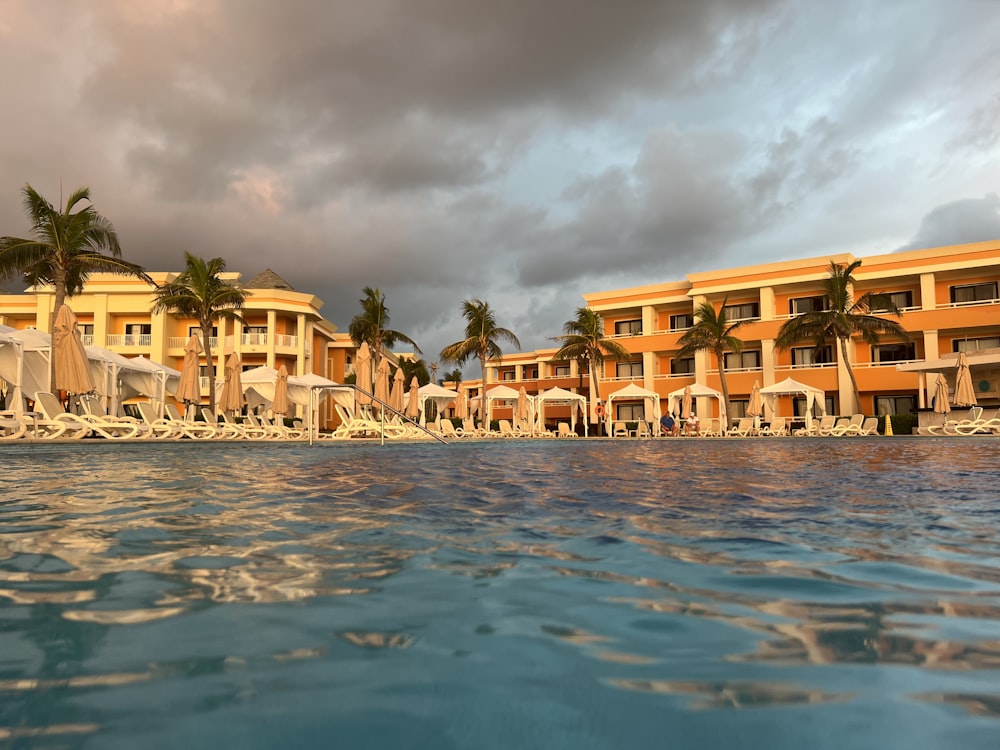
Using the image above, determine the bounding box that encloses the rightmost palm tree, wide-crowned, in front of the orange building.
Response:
[774,260,910,412]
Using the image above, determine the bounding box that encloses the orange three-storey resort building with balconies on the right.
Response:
[463,240,1000,428]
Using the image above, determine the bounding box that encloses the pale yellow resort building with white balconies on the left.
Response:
[0,269,355,424]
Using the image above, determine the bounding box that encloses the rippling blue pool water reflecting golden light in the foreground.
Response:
[0,438,1000,750]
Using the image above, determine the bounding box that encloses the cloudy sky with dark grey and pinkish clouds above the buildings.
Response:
[0,0,1000,371]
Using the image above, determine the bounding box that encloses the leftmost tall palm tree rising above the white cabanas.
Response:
[0,185,153,382]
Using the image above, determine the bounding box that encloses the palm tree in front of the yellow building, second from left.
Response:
[153,252,250,407]
